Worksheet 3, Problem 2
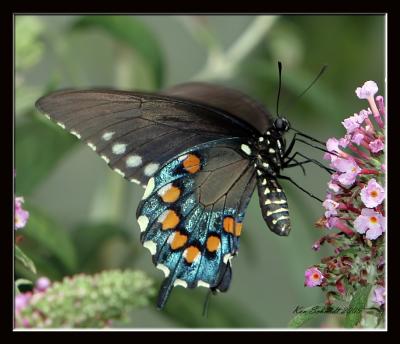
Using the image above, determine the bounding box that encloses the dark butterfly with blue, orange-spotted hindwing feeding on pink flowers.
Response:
[36,78,324,308]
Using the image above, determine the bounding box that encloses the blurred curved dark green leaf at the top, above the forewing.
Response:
[72,16,164,88]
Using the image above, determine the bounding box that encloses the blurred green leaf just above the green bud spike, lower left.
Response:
[24,204,77,272]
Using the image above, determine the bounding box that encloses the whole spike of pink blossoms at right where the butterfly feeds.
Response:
[304,81,386,300]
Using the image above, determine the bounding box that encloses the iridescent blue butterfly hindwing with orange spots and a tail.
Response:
[137,138,256,308]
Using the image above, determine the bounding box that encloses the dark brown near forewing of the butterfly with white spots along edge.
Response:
[36,90,254,185]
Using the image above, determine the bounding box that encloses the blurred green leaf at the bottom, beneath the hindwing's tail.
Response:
[163,288,267,327]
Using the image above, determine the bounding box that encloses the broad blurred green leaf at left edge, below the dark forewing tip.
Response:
[15,116,77,195]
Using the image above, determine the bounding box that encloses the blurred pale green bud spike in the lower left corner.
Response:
[16,270,155,328]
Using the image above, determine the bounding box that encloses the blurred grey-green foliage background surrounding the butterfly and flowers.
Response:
[15,15,385,328]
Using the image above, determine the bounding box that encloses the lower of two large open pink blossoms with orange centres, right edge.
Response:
[354,208,386,240]
